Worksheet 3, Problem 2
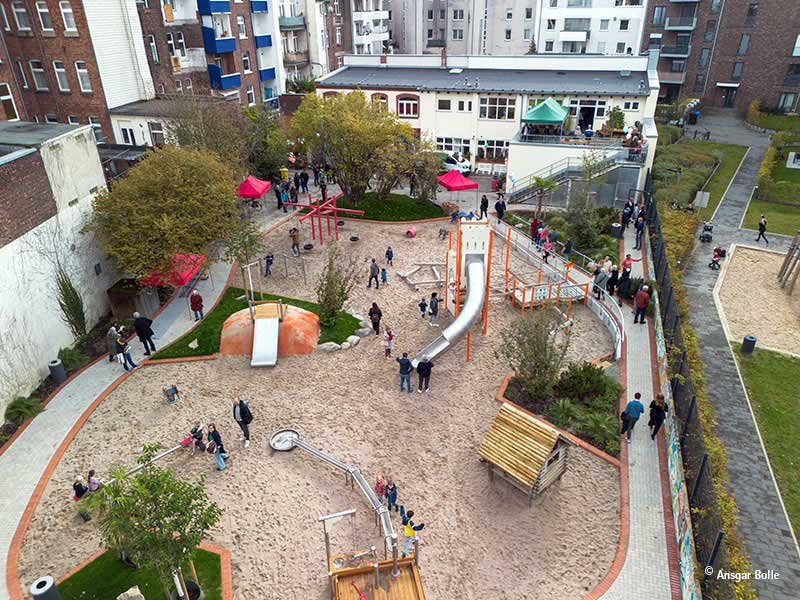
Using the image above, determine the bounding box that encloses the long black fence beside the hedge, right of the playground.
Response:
[636,173,736,600]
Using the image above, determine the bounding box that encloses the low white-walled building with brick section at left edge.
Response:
[0,121,116,406]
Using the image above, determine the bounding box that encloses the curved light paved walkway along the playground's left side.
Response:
[0,209,294,599]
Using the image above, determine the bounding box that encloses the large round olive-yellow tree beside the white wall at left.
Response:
[84,146,241,278]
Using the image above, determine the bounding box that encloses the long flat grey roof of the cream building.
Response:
[317,66,650,96]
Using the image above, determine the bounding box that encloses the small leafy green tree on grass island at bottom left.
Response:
[90,444,222,598]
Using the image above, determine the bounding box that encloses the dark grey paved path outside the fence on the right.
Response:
[683,113,800,600]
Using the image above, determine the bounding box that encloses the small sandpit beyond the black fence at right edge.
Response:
[719,246,800,354]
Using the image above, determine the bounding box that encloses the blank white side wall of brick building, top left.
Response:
[83,0,156,108]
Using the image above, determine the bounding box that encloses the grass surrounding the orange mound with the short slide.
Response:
[153,288,359,359]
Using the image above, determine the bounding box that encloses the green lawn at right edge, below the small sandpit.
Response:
[735,344,800,535]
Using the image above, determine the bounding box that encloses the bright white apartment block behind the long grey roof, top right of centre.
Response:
[535,0,647,54]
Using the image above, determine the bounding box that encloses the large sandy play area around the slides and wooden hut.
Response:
[20,224,619,600]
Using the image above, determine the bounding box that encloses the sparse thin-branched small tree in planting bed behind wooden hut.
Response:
[497,309,569,402]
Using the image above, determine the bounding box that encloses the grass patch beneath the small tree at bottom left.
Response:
[58,550,222,600]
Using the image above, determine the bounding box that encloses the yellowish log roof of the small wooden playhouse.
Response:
[479,403,561,488]
